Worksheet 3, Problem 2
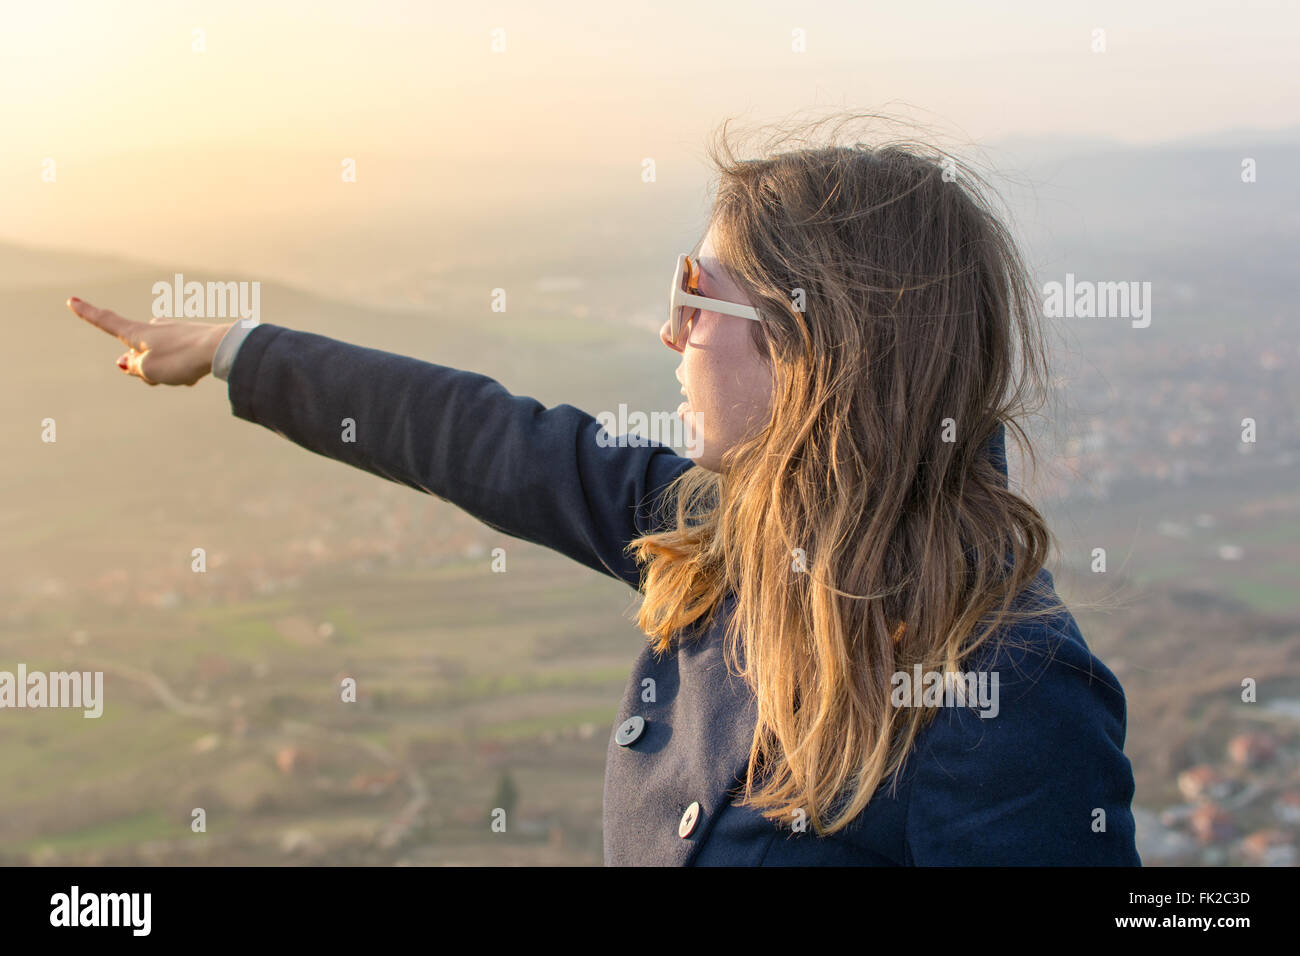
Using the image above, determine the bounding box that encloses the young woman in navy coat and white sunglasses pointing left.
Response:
[69,121,1140,865]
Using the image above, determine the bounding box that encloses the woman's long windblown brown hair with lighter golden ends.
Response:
[629,114,1053,832]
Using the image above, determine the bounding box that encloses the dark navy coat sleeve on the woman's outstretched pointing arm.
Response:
[229,324,693,588]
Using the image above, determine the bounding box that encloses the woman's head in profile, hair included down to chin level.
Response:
[660,121,1043,471]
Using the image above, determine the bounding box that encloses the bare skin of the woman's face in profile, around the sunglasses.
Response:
[659,229,772,471]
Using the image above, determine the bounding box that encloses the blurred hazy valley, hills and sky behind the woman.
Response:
[0,4,1300,865]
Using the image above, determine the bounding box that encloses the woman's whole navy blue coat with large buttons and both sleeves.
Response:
[229,324,1140,866]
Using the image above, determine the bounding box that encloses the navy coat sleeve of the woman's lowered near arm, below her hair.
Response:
[905,618,1141,866]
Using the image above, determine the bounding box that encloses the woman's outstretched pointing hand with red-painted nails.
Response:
[66,298,234,385]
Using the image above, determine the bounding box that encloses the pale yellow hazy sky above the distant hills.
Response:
[0,0,1300,283]
